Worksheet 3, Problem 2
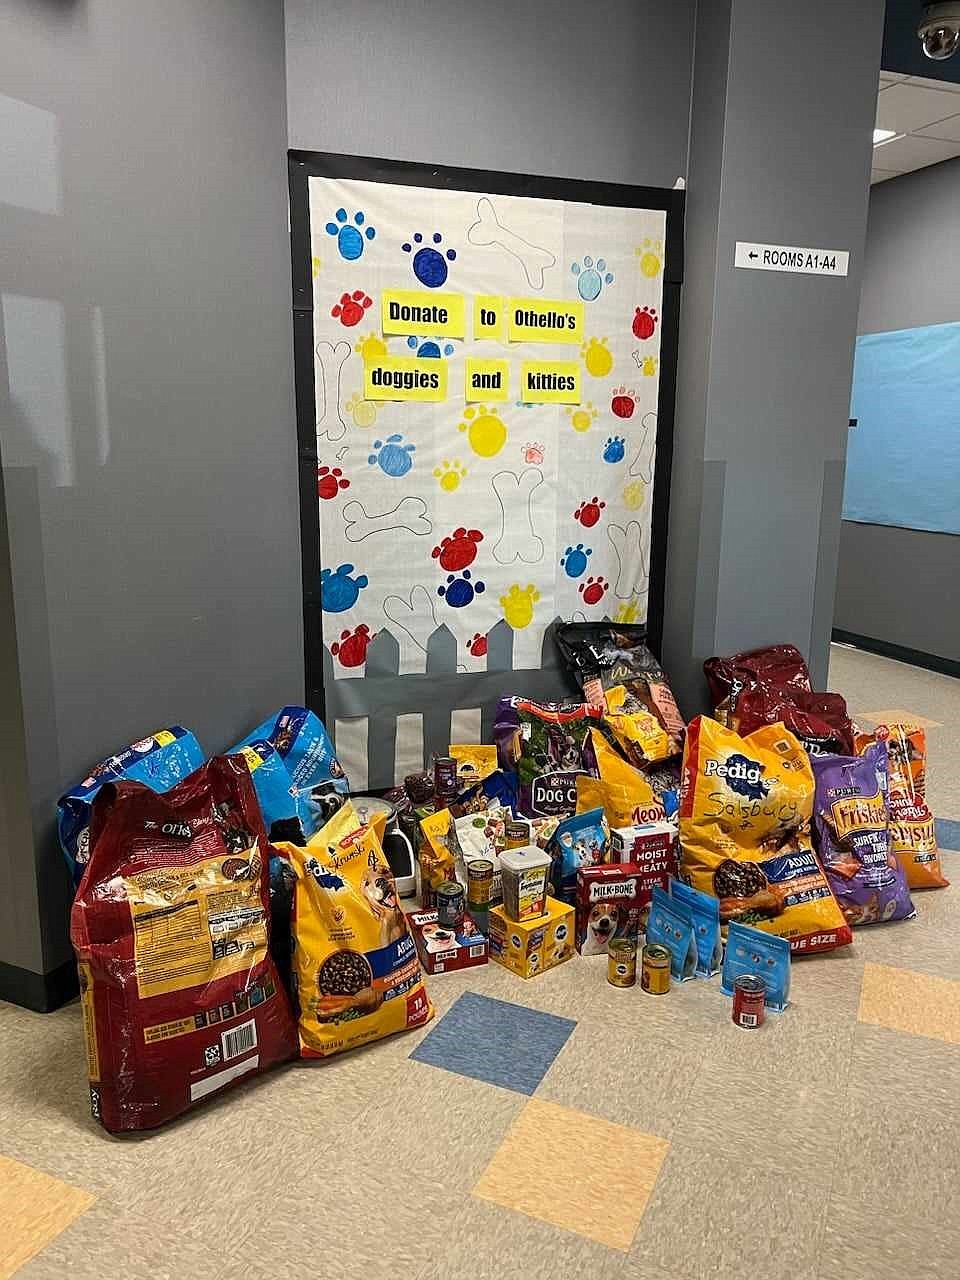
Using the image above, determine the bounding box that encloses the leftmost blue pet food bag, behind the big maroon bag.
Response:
[56,724,204,888]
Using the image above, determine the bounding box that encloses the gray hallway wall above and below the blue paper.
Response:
[835,160,960,660]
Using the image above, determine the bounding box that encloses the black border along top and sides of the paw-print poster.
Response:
[288,151,684,719]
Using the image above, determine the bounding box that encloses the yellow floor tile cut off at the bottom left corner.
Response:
[0,1156,96,1280]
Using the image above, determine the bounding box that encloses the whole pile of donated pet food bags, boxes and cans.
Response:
[59,623,947,1132]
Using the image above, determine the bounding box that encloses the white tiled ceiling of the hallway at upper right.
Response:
[870,72,960,183]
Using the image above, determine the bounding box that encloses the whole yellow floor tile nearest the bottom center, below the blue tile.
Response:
[474,1098,669,1252]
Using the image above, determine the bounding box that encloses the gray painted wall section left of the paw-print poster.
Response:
[0,0,303,972]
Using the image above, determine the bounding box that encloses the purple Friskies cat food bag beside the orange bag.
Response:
[813,742,916,927]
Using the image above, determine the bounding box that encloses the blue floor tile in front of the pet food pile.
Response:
[410,992,576,1094]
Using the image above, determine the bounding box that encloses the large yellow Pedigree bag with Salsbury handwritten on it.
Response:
[680,716,852,954]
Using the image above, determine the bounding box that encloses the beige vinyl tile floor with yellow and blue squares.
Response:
[0,646,960,1280]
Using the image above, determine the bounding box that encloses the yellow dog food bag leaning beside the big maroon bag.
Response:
[278,804,434,1057]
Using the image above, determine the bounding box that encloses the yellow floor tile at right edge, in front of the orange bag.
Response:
[859,964,960,1044]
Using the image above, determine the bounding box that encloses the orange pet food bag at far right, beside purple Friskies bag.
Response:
[856,723,950,890]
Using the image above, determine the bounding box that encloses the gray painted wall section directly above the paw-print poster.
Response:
[284,0,695,187]
